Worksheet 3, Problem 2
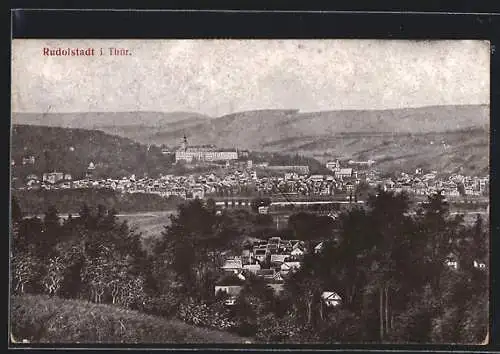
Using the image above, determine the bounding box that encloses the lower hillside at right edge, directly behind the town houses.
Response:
[306,127,490,175]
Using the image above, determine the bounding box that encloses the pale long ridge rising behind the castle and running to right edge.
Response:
[142,106,489,150]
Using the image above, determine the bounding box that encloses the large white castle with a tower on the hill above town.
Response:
[175,136,238,163]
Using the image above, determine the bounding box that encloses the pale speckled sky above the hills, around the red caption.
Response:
[12,39,490,117]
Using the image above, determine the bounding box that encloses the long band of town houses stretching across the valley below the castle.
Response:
[13,156,489,199]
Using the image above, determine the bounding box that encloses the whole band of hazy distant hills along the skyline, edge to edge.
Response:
[12,105,489,149]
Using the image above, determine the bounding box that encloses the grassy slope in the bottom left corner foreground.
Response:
[10,295,254,344]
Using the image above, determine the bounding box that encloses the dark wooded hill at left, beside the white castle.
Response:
[11,125,176,179]
